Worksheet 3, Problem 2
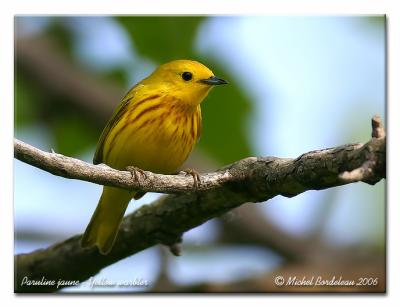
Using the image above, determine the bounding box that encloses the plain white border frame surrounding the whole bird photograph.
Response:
[0,0,400,307]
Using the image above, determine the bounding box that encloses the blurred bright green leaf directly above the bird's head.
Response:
[117,16,204,63]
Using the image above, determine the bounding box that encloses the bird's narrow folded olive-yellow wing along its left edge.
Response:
[93,85,138,164]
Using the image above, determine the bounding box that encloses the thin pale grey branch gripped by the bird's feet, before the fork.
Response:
[14,139,233,193]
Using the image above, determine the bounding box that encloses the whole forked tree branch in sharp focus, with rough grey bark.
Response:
[14,118,386,292]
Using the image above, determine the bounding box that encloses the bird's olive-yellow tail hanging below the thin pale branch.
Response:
[81,187,133,255]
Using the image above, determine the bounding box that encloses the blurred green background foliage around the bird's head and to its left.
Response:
[15,16,251,164]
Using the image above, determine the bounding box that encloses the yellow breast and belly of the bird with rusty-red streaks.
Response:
[106,103,201,173]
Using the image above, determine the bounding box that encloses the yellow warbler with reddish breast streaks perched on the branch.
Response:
[81,60,227,254]
